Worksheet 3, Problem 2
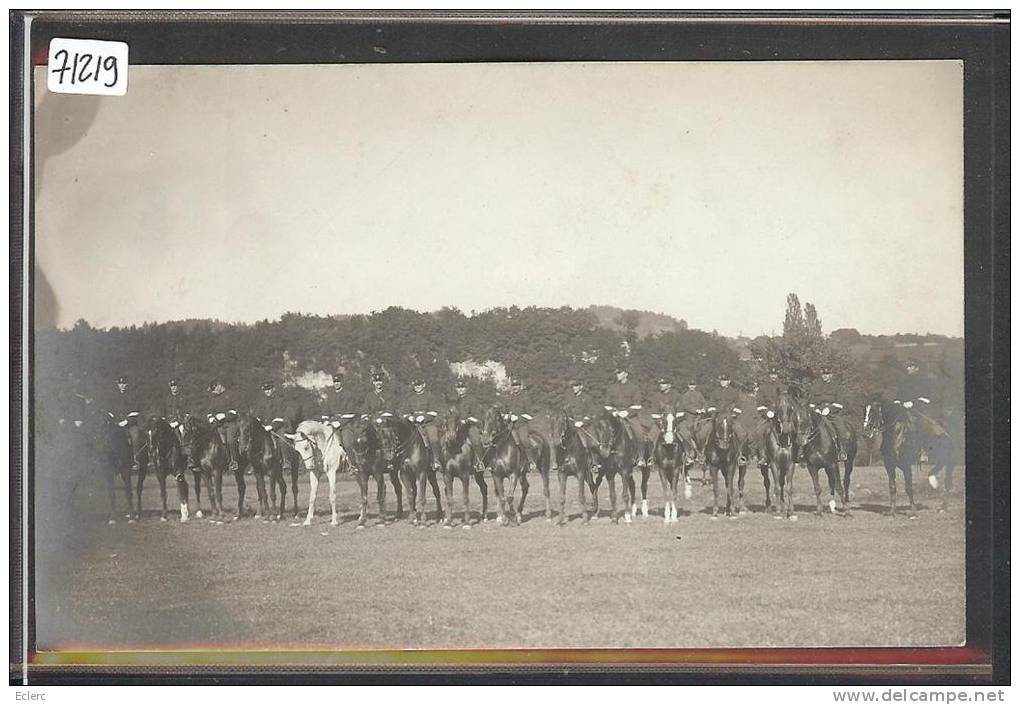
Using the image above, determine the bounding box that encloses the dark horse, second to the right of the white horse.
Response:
[376,413,443,526]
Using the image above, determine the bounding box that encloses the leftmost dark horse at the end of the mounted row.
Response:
[66,414,133,524]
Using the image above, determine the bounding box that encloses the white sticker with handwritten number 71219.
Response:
[46,38,128,96]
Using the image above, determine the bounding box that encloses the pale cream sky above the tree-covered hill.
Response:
[36,61,963,336]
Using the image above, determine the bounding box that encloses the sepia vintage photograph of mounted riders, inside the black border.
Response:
[30,60,962,657]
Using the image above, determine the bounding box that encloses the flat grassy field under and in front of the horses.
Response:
[36,461,964,649]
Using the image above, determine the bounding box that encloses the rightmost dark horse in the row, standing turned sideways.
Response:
[864,397,953,519]
